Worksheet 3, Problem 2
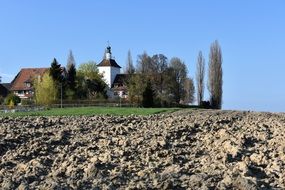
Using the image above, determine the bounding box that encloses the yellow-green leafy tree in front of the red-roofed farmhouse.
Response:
[34,73,58,106]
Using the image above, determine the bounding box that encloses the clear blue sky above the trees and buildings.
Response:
[0,0,285,112]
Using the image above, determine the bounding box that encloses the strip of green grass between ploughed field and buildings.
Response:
[0,107,180,117]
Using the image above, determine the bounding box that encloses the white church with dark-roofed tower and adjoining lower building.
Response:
[97,46,128,98]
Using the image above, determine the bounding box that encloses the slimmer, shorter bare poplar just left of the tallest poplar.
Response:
[196,51,205,105]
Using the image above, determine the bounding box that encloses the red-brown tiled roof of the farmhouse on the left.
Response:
[11,68,49,91]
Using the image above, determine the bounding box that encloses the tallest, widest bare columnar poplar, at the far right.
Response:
[208,40,223,109]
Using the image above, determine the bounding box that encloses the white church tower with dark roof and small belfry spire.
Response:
[97,46,121,88]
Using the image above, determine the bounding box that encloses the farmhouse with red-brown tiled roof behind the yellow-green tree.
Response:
[10,68,49,99]
